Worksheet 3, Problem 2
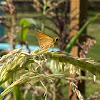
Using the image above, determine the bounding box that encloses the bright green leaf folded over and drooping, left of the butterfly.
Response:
[20,18,40,41]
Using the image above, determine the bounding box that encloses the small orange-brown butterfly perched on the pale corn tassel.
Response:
[36,31,59,50]
